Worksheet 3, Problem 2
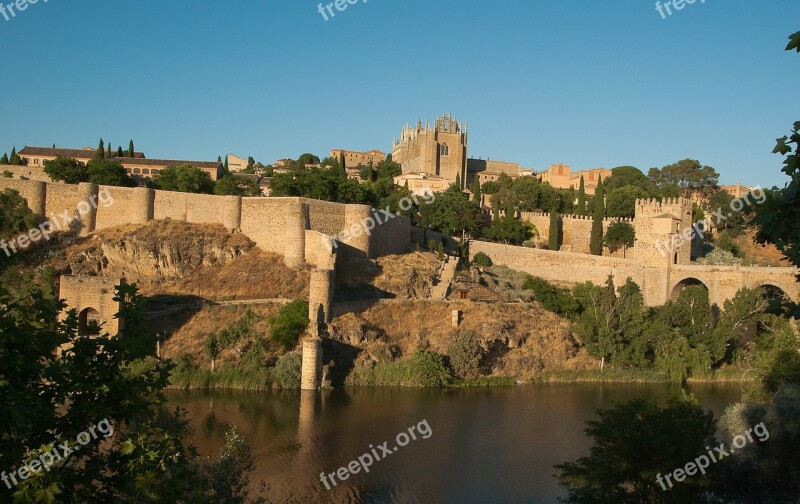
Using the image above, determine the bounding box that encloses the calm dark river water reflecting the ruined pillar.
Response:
[168,384,741,504]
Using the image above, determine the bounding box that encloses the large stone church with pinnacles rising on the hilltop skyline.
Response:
[392,115,468,189]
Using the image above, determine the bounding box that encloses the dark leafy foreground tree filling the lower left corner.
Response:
[0,282,260,504]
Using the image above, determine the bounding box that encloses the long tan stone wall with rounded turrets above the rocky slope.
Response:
[0,178,411,268]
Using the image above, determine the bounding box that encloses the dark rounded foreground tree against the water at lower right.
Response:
[556,398,716,504]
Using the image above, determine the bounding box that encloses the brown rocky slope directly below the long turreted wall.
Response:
[40,220,308,300]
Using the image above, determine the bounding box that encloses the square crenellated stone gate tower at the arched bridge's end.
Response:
[630,198,695,267]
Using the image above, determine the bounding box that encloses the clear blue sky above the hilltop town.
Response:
[0,0,800,185]
